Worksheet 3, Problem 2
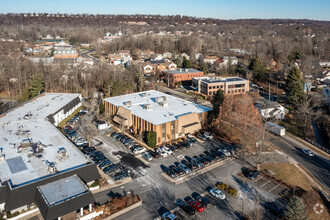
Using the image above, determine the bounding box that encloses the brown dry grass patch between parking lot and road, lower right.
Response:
[261,163,315,191]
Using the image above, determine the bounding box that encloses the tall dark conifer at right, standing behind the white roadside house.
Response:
[286,67,305,106]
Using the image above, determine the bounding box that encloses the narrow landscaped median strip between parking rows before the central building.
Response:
[161,157,233,185]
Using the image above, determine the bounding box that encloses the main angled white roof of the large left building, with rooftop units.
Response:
[0,93,89,188]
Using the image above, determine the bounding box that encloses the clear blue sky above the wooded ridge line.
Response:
[0,0,330,21]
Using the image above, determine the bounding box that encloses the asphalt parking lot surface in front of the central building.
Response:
[66,108,283,219]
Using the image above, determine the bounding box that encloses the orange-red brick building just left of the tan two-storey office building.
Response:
[163,69,204,86]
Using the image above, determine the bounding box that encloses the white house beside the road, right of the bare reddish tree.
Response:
[255,98,289,120]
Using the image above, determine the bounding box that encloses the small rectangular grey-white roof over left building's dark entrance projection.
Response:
[39,175,88,206]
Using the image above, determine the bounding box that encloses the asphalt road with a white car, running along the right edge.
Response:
[268,135,330,191]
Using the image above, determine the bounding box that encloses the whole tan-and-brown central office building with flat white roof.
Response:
[103,90,211,145]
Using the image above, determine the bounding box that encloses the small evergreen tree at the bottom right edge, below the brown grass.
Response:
[285,195,309,220]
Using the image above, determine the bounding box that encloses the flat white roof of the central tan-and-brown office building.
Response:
[104,90,212,125]
